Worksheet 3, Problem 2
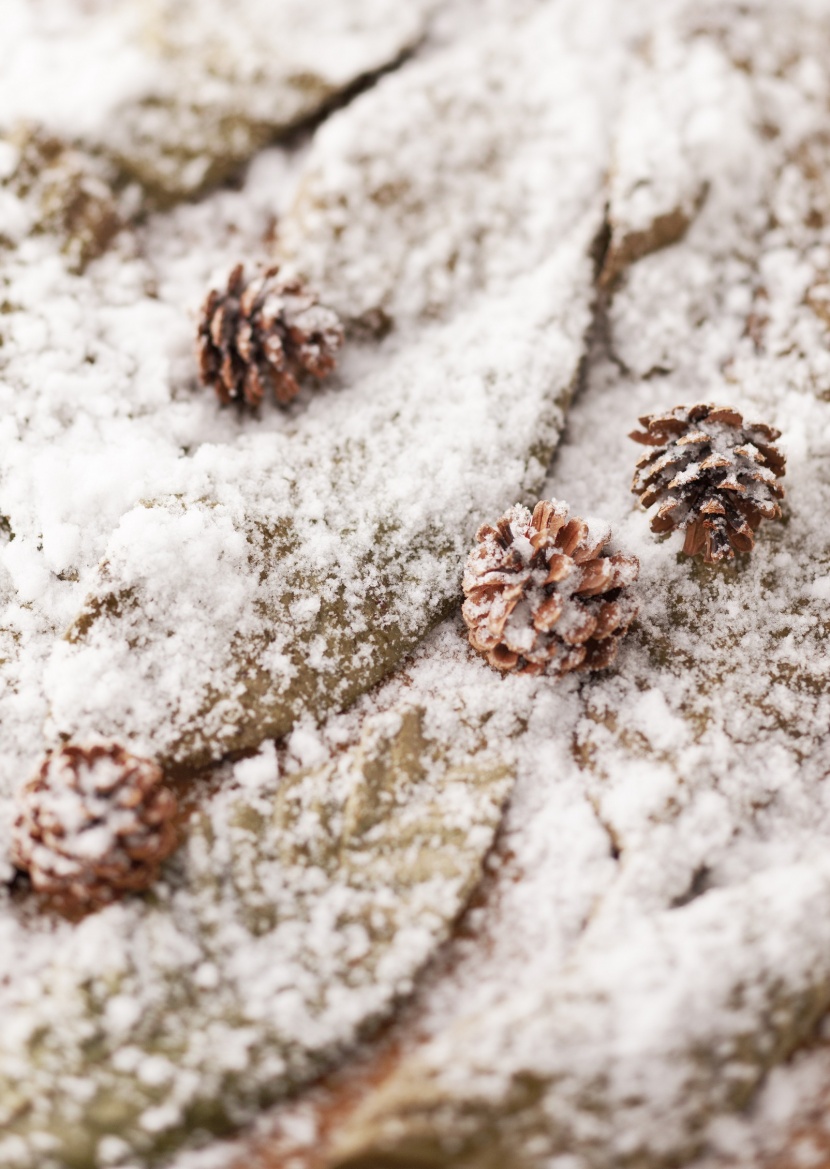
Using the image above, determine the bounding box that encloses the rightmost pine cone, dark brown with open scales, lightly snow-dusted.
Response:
[631,403,786,565]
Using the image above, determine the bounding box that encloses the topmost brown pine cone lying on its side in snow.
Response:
[198,264,344,407]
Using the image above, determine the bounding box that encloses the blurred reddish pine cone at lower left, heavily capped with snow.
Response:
[12,743,178,909]
